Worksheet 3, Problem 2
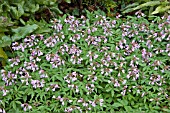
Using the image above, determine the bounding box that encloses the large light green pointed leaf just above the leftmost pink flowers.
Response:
[12,24,38,41]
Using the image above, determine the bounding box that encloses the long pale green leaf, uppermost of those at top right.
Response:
[133,1,161,10]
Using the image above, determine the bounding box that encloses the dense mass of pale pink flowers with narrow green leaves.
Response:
[0,11,170,113]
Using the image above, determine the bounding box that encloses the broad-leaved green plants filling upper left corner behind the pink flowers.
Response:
[0,0,65,65]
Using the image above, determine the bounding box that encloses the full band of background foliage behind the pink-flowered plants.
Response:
[0,0,170,65]
